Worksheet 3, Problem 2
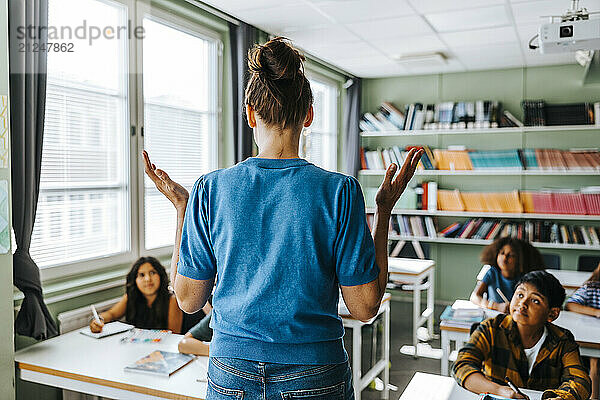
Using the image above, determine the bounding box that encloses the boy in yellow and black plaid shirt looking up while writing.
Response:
[452,271,590,400]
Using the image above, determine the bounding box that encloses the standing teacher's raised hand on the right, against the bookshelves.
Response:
[375,148,423,213]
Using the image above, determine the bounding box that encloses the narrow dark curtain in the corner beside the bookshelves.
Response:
[344,78,361,176]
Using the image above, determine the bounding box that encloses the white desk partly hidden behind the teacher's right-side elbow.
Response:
[340,293,392,400]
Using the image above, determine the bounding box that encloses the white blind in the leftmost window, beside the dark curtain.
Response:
[31,0,131,268]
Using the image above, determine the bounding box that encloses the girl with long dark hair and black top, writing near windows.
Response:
[90,257,183,333]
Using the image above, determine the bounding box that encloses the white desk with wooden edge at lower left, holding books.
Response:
[15,331,208,400]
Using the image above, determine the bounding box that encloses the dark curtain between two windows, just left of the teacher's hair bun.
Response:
[229,21,258,163]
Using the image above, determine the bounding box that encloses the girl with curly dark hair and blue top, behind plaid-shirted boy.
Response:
[469,237,544,313]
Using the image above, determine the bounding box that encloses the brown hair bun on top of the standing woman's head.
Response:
[248,37,304,81]
